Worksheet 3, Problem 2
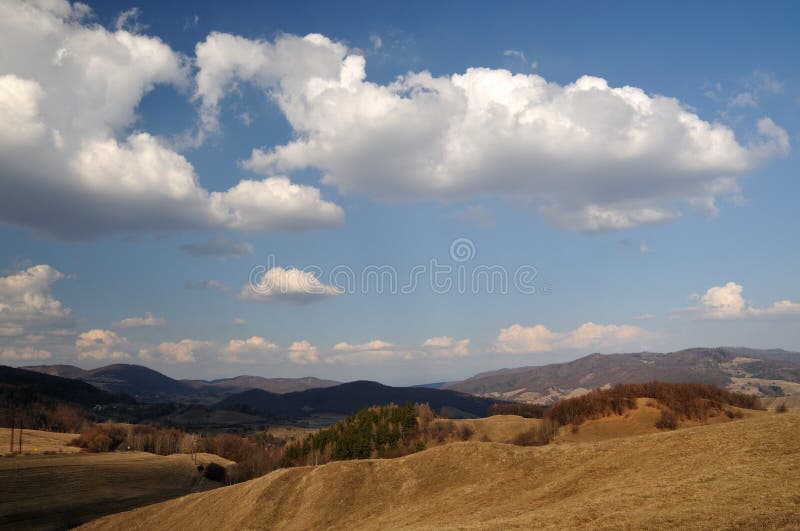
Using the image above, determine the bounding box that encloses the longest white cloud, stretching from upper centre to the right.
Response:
[196,33,789,231]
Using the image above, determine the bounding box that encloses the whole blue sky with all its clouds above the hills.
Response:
[0,0,800,385]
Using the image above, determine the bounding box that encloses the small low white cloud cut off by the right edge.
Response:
[690,282,800,320]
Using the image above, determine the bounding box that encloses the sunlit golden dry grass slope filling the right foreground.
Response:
[78,412,800,531]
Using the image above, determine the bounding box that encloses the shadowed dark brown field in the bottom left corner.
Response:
[0,448,231,529]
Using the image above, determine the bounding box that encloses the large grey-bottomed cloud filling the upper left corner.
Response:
[0,0,343,239]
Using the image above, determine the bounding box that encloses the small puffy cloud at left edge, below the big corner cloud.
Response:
[0,264,72,336]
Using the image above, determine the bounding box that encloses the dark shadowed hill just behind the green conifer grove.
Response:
[216,381,495,419]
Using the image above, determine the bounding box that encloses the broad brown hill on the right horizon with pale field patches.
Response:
[446,347,800,404]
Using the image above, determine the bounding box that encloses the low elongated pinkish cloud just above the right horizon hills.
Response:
[495,322,649,354]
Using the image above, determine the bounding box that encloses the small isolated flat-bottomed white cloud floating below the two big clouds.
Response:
[244,267,341,302]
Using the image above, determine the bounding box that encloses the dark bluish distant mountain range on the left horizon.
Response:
[22,363,340,404]
